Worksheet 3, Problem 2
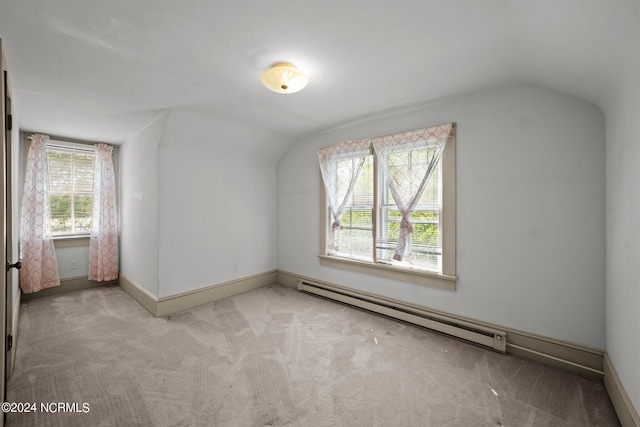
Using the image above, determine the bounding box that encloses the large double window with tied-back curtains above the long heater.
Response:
[318,124,456,289]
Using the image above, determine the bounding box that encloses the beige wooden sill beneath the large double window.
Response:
[318,255,458,291]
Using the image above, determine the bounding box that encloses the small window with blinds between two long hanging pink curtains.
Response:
[46,145,95,237]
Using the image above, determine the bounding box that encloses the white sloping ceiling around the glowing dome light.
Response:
[0,0,640,143]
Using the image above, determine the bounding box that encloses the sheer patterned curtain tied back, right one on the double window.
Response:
[371,124,453,261]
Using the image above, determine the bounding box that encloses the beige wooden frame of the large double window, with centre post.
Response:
[318,124,458,290]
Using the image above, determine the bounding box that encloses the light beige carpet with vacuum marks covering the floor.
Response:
[7,285,619,427]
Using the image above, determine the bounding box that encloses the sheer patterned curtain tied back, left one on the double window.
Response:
[318,140,371,254]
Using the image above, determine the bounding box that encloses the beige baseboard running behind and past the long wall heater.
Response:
[276,270,604,379]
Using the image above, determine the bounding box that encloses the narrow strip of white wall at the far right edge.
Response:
[606,84,640,411]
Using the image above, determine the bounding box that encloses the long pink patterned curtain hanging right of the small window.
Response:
[89,144,118,282]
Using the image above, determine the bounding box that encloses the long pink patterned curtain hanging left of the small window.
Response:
[20,135,60,293]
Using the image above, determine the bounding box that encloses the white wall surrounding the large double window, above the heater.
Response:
[278,86,605,349]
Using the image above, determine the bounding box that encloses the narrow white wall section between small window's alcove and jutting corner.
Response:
[119,113,168,296]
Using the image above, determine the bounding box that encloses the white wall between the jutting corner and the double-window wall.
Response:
[159,109,285,297]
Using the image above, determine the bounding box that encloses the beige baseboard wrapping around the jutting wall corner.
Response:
[120,270,276,317]
